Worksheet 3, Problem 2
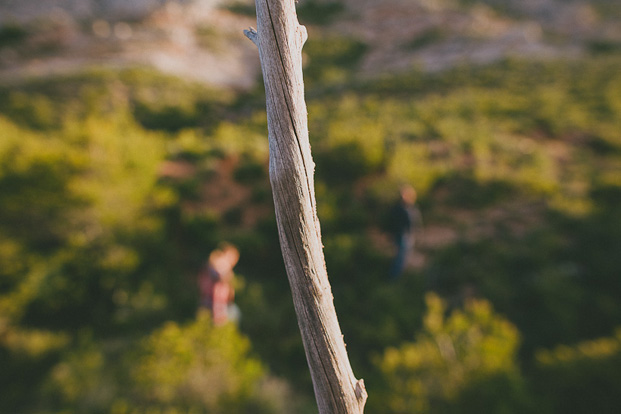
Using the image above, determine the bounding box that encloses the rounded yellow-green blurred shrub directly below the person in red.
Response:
[133,313,264,412]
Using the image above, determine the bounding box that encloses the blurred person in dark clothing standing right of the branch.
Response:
[389,185,422,280]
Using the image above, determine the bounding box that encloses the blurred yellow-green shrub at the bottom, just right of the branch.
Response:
[370,294,527,413]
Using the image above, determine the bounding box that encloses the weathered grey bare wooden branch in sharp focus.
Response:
[245,0,367,414]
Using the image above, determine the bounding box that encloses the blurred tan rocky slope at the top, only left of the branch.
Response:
[0,0,258,88]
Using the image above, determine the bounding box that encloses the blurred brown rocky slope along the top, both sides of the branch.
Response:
[0,0,621,89]
